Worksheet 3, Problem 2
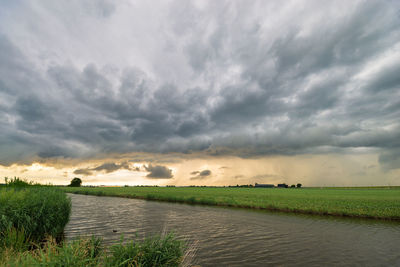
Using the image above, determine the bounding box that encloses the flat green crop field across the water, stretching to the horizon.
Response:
[63,187,400,220]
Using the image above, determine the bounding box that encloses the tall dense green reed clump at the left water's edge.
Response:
[0,186,71,246]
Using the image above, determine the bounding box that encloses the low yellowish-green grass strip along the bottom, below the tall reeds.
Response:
[0,234,184,267]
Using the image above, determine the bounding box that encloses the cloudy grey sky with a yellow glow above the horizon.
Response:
[0,0,400,186]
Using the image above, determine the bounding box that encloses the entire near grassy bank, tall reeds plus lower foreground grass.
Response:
[0,179,184,267]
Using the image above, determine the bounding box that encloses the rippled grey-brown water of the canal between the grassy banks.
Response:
[65,194,400,266]
